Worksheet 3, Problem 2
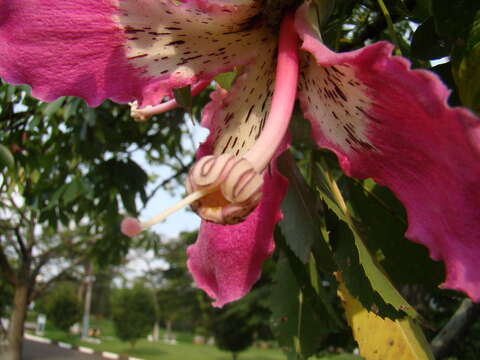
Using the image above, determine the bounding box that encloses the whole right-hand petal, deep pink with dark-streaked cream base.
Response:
[296,7,480,301]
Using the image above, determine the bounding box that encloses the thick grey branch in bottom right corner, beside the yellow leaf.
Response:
[431,299,480,360]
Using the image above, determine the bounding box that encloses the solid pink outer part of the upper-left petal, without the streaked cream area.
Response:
[0,0,143,105]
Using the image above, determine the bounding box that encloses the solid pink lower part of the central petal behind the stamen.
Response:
[187,138,288,307]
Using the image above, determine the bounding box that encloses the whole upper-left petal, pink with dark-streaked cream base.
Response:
[0,0,269,106]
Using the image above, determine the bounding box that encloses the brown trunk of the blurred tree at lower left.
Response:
[2,283,28,360]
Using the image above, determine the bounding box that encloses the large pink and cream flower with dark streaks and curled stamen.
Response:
[0,0,480,306]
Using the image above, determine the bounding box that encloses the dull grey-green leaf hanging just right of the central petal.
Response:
[278,152,335,273]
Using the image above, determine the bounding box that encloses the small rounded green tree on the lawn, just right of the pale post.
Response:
[112,285,155,348]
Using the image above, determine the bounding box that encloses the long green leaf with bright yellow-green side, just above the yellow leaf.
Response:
[316,162,418,318]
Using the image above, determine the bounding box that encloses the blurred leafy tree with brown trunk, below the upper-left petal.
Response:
[0,83,188,360]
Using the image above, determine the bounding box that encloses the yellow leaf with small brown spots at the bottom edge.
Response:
[337,274,434,360]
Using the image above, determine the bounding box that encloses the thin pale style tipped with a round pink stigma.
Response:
[121,187,216,237]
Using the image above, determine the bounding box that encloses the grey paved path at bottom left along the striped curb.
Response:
[22,340,102,360]
